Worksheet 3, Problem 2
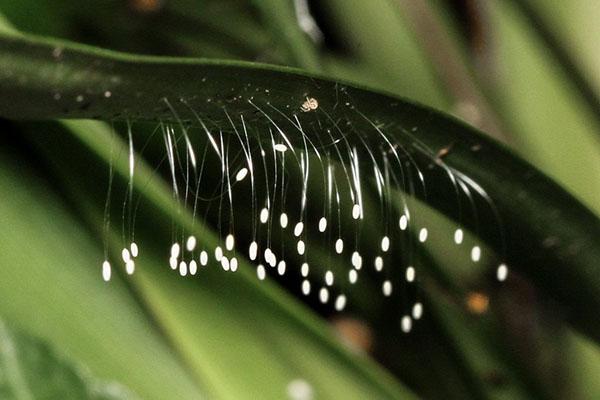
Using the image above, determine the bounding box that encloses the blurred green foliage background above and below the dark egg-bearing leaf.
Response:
[0,0,600,399]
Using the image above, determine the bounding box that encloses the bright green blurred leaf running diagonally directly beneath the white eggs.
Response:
[22,121,418,399]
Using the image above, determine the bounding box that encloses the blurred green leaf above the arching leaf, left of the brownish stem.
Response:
[316,0,451,111]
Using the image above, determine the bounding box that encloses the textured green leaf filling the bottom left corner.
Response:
[0,320,137,400]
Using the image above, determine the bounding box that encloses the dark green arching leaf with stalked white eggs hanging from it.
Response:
[0,32,600,346]
